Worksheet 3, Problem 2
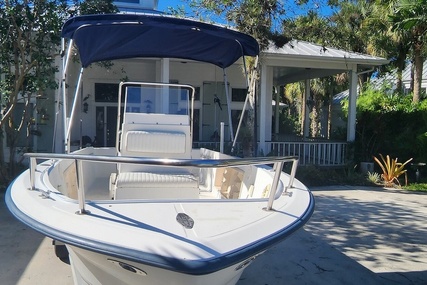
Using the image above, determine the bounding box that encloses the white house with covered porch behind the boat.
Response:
[2,0,388,165]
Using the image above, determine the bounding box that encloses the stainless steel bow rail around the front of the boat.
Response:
[24,153,298,214]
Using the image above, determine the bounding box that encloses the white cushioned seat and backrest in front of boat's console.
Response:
[110,112,199,199]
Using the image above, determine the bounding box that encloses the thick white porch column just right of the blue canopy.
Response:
[258,64,273,155]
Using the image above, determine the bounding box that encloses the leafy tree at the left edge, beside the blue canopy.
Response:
[0,0,117,178]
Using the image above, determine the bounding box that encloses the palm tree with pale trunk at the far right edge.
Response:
[390,0,427,103]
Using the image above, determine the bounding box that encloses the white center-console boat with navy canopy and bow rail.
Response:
[5,13,314,285]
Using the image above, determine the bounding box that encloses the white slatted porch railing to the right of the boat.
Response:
[266,141,347,166]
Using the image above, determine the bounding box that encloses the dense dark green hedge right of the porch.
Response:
[343,82,427,163]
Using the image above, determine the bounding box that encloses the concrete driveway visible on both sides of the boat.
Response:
[0,186,427,285]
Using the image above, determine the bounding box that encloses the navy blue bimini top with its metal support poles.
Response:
[58,14,259,152]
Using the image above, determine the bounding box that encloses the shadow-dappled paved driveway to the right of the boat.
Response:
[238,186,427,285]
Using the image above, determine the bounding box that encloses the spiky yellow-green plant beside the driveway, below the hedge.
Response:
[374,154,412,187]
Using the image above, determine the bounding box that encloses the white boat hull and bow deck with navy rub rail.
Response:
[6,149,314,285]
